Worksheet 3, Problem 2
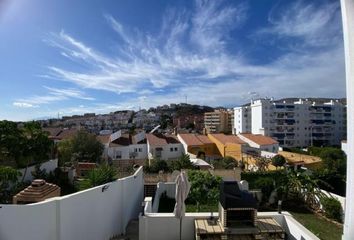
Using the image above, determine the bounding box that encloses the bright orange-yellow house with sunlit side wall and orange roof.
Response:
[208,133,247,161]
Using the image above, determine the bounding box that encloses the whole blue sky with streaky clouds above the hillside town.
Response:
[0,0,345,120]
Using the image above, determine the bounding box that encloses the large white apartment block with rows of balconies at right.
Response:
[234,98,346,147]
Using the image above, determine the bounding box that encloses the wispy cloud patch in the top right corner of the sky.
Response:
[257,1,341,48]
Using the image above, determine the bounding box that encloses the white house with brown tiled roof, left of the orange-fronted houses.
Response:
[146,133,183,160]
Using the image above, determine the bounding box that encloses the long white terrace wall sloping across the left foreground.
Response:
[0,167,144,240]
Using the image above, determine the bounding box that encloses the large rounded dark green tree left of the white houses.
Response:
[58,131,104,165]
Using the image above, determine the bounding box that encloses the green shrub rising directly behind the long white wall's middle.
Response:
[78,165,117,190]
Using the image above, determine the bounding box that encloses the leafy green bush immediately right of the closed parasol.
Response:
[186,170,221,211]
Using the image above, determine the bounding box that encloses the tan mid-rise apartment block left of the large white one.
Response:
[204,109,234,133]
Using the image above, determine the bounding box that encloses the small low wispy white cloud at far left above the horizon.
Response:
[13,86,95,108]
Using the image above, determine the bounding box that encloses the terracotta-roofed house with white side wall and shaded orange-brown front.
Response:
[177,133,221,160]
